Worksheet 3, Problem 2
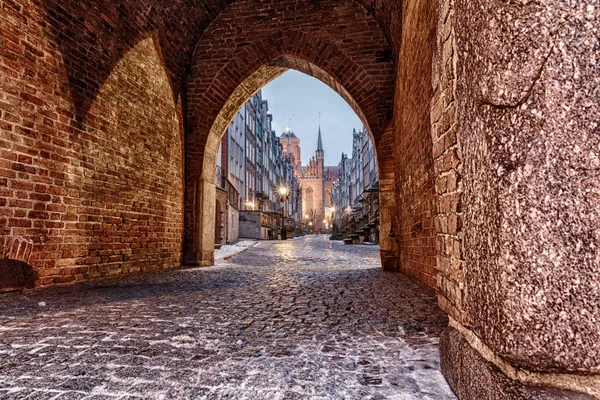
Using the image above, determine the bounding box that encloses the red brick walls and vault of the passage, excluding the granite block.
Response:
[0,0,435,287]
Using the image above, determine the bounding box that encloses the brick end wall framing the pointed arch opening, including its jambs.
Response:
[185,0,397,268]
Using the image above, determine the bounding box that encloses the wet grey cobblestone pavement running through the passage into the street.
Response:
[0,236,455,400]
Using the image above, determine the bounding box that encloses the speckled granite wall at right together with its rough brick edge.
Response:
[432,0,600,399]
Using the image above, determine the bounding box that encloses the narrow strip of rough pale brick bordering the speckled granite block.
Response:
[431,0,465,321]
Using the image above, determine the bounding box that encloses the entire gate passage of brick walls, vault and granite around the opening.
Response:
[0,0,600,400]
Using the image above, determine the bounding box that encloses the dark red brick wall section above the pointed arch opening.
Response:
[187,0,395,175]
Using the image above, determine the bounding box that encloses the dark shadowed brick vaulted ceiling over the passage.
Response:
[41,0,400,120]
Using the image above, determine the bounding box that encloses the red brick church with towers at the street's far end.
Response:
[280,127,339,231]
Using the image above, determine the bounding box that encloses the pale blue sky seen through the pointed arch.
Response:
[262,70,363,165]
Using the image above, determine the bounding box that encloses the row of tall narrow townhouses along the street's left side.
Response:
[215,91,302,244]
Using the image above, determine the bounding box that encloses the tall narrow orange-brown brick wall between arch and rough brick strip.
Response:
[394,0,437,292]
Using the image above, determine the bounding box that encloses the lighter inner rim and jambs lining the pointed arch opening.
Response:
[185,55,397,269]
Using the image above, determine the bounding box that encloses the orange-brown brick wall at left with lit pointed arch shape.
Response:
[0,0,183,284]
